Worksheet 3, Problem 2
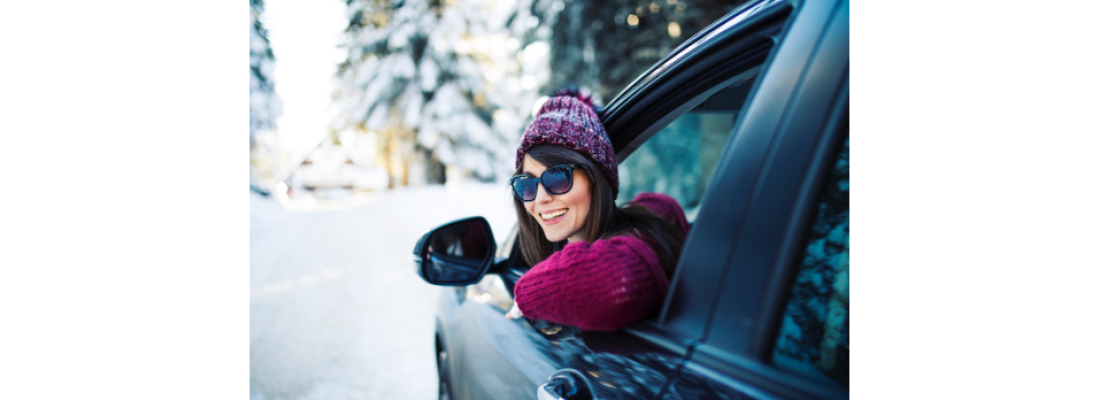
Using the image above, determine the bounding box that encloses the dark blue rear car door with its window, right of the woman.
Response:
[662,0,850,399]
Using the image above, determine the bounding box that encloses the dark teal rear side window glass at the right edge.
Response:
[772,132,850,387]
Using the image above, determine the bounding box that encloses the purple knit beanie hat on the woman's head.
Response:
[516,89,618,199]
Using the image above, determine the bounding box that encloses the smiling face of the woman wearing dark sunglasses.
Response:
[524,156,592,242]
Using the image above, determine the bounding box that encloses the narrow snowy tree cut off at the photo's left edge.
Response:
[249,0,283,190]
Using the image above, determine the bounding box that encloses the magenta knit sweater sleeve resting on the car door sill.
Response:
[515,236,669,331]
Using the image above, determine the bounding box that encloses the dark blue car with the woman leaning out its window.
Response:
[414,0,850,399]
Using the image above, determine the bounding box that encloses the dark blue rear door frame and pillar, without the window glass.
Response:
[661,0,850,398]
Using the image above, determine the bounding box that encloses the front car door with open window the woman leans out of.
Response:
[438,1,805,399]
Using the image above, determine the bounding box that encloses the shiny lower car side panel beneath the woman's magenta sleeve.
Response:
[438,278,683,399]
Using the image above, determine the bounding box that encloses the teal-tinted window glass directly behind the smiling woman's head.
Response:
[618,69,757,219]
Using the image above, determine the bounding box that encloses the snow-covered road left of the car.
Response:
[249,184,515,400]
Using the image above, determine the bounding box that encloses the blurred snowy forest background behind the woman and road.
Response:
[249,0,744,195]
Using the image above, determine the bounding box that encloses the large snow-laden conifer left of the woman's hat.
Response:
[336,0,549,185]
